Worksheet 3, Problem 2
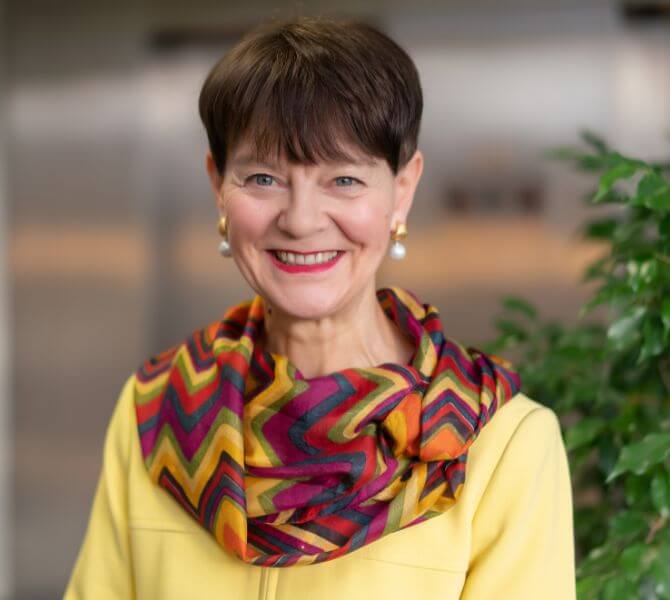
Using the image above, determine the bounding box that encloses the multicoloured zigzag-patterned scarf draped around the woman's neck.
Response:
[135,287,521,567]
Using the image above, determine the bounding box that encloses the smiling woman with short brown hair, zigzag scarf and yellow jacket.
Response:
[65,18,575,600]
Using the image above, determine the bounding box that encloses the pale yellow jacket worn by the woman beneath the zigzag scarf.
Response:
[64,375,576,600]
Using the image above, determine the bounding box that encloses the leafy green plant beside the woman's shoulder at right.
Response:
[483,133,670,600]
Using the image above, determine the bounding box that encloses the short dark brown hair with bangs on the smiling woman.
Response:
[199,16,423,174]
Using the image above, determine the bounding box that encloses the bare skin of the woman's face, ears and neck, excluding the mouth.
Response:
[205,143,423,378]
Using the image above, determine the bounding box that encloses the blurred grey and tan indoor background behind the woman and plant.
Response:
[0,0,670,600]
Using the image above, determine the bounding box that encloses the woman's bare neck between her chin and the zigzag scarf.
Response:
[261,281,414,378]
